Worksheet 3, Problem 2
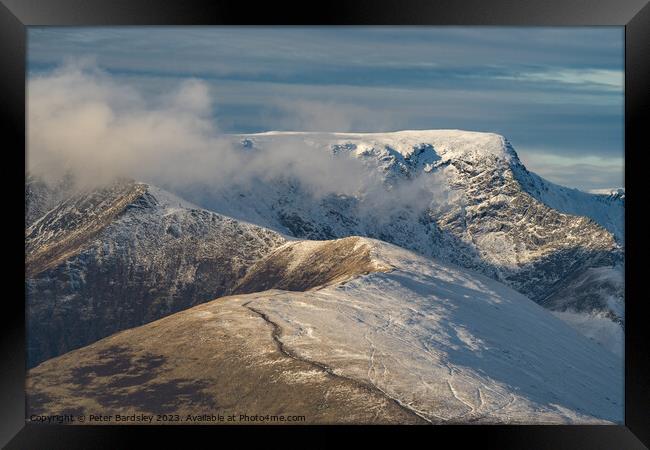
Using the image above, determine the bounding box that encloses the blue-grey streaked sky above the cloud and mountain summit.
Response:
[27,27,624,190]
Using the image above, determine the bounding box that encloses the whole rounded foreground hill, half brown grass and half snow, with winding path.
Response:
[27,237,623,424]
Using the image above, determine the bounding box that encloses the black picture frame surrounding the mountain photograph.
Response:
[0,0,650,449]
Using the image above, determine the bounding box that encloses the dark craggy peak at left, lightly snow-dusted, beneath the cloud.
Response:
[25,182,285,366]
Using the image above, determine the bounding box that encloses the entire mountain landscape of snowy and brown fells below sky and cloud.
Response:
[25,130,625,423]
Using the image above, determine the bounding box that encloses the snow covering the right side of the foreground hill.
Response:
[247,239,623,423]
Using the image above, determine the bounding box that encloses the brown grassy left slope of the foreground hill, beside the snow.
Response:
[27,291,423,423]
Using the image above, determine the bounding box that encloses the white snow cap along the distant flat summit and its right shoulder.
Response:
[228,130,624,242]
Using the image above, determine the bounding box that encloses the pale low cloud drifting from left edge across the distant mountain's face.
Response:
[27,61,450,217]
